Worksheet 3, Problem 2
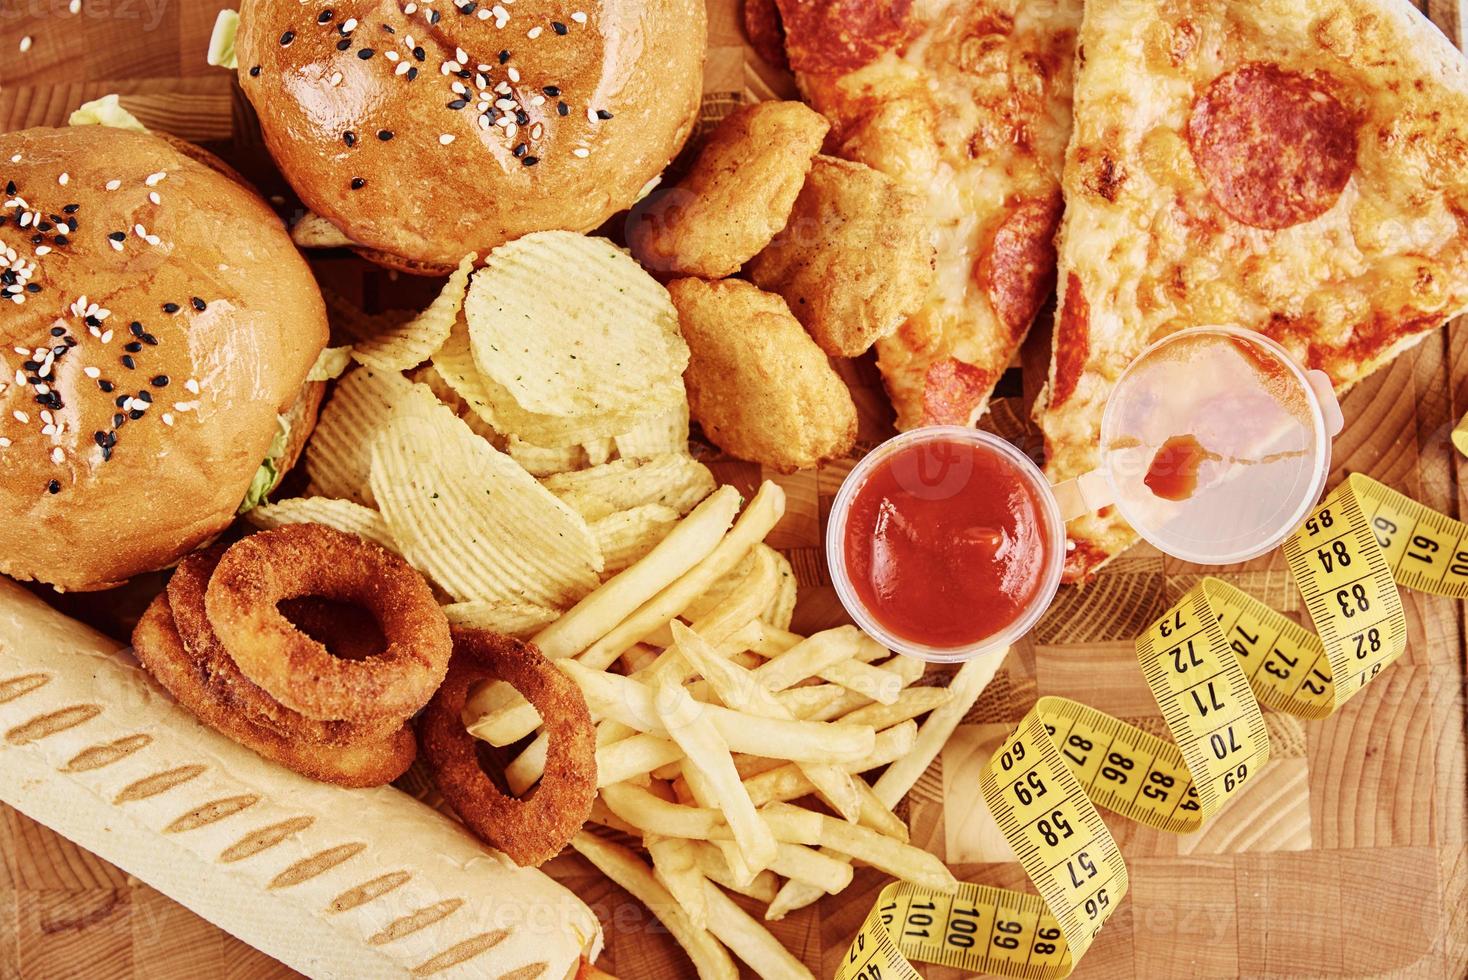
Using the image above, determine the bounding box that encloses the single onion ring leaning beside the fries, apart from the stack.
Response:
[418,629,596,867]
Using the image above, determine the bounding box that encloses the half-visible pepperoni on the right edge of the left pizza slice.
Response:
[978,194,1061,340]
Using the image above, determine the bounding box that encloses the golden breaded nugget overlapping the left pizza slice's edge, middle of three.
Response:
[749,157,935,358]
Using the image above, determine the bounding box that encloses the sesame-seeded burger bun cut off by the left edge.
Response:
[0,126,327,591]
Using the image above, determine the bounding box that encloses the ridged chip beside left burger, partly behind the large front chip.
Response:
[305,367,413,506]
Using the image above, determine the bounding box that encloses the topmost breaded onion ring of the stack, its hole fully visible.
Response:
[204,524,452,723]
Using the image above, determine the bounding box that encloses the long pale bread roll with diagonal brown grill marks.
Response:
[0,579,602,980]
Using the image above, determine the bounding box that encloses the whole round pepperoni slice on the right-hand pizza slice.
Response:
[1188,62,1356,230]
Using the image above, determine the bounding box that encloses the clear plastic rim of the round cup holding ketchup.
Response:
[826,425,1066,663]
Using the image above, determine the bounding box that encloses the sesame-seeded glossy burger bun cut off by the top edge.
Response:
[235,0,708,274]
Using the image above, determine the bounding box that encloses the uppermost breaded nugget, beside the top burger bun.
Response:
[627,103,831,279]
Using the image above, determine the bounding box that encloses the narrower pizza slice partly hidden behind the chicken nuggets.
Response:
[780,0,1080,428]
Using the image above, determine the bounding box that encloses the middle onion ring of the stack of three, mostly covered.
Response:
[167,544,407,745]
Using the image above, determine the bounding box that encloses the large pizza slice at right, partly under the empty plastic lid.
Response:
[1036,0,1468,581]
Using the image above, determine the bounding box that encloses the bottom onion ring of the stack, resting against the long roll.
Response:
[132,593,417,788]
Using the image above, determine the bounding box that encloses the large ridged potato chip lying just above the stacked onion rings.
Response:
[371,389,602,607]
